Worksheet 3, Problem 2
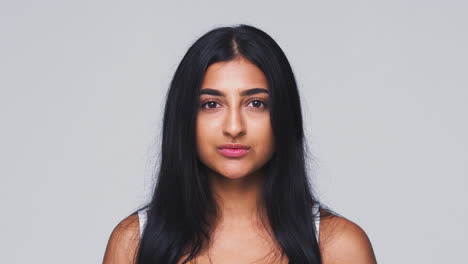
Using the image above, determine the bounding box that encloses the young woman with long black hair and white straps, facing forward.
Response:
[104,25,376,264]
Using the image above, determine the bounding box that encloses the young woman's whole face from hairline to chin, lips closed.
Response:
[196,58,274,179]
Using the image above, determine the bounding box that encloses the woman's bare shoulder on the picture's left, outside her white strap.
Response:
[103,214,140,264]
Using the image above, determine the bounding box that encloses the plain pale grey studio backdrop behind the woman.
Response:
[0,0,468,264]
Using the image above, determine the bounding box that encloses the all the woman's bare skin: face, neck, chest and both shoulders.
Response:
[103,57,376,264]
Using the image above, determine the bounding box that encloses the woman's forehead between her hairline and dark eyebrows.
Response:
[201,58,268,90]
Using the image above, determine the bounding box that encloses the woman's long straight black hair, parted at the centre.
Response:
[134,24,321,264]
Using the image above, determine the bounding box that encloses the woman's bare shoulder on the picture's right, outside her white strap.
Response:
[319,211,377,264]
